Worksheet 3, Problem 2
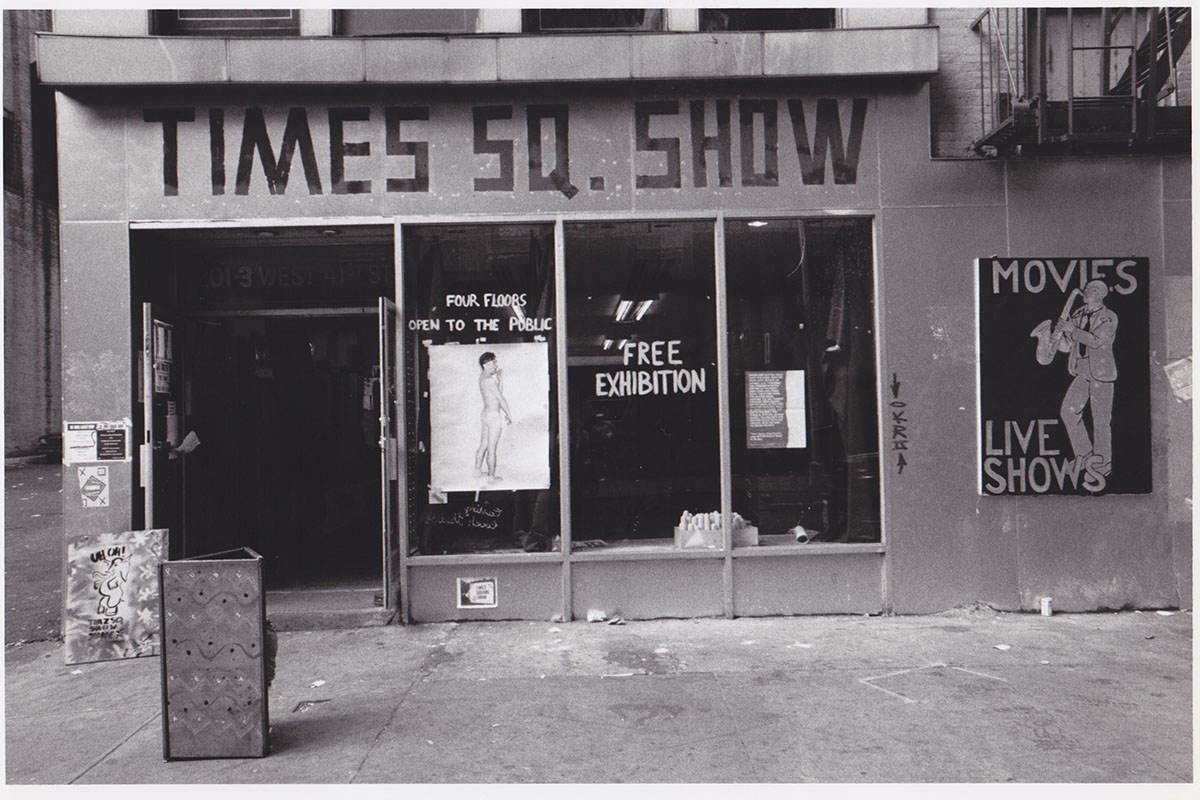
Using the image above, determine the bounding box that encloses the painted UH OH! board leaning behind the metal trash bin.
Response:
[64,529,167,663]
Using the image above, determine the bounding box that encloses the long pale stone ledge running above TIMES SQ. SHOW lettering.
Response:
[37,25,937,86]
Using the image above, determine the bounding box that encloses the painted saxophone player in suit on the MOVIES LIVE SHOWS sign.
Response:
[1031,281,1117,476]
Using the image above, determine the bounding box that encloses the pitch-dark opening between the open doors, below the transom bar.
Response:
[184,311,383,589]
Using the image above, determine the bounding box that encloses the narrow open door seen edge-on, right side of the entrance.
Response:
[378,297,402,608]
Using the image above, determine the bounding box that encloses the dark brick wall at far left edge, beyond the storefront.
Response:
[4,10,62,455]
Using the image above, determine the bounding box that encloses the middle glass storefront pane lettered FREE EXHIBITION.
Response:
[564,221,720,551]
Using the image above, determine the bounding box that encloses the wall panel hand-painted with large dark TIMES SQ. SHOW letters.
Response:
[117,95,878,216]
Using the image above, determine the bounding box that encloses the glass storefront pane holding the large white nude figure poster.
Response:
[403,224,559,554]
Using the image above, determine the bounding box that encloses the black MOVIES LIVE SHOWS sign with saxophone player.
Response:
[976,257,1152,495]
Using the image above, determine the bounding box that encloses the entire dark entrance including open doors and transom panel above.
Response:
[131,223,400,627]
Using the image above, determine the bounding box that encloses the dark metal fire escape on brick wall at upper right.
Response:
[971,7,1192,155]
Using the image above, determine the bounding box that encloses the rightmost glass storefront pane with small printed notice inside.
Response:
[725,218,881,545]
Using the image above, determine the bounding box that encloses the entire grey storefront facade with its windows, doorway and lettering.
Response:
[40,14,1190,622]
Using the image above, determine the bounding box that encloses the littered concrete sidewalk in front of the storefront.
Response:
[5,609,1193,784]
